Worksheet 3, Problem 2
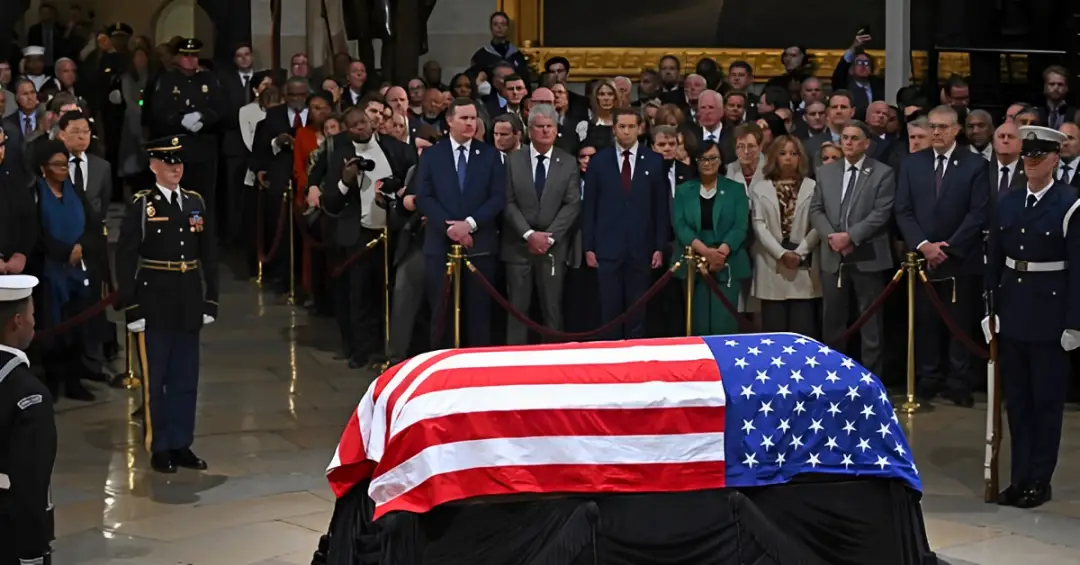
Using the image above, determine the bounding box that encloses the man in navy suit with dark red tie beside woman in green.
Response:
[582,109,671,339]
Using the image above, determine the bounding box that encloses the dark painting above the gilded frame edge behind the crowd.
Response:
[543,0,926,50]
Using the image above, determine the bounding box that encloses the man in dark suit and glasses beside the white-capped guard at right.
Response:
[896,106,989,406]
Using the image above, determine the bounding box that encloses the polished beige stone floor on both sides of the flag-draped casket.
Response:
[46,267,1080,565]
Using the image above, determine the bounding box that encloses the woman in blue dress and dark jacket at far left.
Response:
[33,140,106,401]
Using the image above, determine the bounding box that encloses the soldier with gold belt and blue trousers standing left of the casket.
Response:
[116,137,218,473]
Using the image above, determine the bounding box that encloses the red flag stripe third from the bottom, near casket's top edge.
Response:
[411,359,720,399]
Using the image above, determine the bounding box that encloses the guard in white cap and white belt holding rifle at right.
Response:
[983,125,1080,508]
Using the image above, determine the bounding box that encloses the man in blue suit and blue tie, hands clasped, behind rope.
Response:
[416,98,507,348]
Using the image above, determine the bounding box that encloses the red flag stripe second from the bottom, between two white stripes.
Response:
[375,406,725,476]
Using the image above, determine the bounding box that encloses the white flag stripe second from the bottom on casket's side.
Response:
[390,380,726,438]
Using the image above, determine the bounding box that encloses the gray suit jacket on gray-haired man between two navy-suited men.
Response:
[501,145,581,263]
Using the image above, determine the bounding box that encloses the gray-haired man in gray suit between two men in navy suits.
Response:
[500,105,581,345]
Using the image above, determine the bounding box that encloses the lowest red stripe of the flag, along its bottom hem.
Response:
[374,461,725,520]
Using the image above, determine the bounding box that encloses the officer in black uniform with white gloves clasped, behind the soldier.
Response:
[150,39,229,230]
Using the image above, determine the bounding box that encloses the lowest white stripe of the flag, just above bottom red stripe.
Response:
[368,432,724,505]
